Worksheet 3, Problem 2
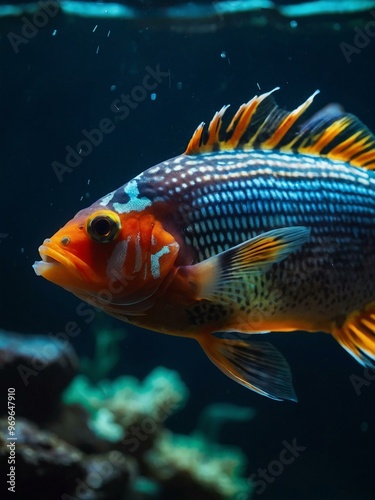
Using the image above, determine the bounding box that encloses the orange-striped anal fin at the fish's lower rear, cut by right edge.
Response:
[332,302,375,368]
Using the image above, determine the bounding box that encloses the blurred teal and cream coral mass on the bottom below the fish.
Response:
[64,367,254,500]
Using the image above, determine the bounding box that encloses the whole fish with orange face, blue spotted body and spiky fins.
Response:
[33,87,375,401]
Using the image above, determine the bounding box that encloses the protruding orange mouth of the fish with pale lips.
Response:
[33,240,88,286]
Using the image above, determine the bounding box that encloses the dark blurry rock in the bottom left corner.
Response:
[0,418,136,500]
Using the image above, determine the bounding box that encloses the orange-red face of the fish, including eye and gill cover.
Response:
[34,206,179,314]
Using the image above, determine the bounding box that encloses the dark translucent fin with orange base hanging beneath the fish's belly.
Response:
[197,335,297,401]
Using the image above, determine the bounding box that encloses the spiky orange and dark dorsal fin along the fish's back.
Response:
[185,87,375,169]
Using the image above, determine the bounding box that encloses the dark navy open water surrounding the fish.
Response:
[0,1,375,500]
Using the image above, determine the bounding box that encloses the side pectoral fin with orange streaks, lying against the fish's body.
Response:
[184,226,310,300]
